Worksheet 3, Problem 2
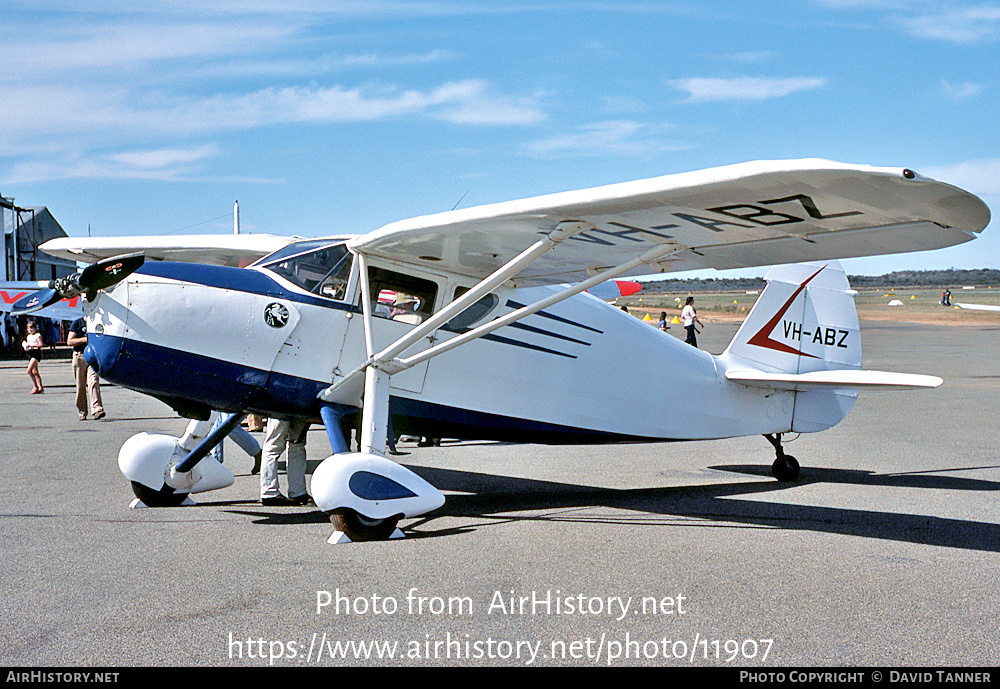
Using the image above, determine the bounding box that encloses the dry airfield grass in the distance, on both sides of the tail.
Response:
[613,285,1000,325]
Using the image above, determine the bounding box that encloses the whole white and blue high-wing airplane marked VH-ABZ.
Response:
[19,160,990,540]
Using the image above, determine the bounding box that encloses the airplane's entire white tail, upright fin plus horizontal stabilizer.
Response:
[720,261,942,432]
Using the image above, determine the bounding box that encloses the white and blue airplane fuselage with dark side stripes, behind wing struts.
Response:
[87,242,794,443]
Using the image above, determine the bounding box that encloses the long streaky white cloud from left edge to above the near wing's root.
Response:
[0,80,544,148]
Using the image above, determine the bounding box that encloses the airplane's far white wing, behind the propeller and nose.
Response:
[39,234,295,267]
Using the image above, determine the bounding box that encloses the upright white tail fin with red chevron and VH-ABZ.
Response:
[723,261,861,374]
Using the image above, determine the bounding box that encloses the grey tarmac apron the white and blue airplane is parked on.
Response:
[0,322,1000,670]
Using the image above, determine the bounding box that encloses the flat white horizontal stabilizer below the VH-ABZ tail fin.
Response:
[726,369,944,390]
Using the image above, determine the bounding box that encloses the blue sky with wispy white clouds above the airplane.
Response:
[0,0,1000,277]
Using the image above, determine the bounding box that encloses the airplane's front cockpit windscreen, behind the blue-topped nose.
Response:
[260,242,352,300]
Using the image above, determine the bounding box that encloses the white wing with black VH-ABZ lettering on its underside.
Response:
[348,160,990,286]
